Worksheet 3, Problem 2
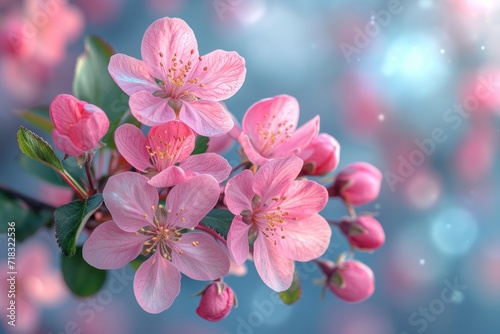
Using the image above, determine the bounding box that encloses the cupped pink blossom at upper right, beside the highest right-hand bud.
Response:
[238,95,319,166]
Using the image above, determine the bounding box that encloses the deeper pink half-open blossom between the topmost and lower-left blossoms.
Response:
[115,121,231,187]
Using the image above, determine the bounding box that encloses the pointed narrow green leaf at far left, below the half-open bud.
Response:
[17,126,64,172]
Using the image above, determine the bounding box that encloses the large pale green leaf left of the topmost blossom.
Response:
[73,36,129,148]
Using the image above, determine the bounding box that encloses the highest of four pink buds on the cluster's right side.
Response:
[299,133,340,175]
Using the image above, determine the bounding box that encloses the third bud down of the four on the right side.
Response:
[340,216,385,251]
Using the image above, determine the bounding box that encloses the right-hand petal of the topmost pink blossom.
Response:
[190,50,246,101]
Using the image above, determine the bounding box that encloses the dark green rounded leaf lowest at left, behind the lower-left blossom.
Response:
[61,246,106,297]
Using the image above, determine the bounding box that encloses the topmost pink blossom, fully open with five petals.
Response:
[108,17,246,136]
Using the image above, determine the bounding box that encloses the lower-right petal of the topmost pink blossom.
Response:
[179,100,234,137]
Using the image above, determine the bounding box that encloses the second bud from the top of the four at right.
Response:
[328,162,382,205]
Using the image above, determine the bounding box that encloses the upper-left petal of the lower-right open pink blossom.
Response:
[225,169,255,215]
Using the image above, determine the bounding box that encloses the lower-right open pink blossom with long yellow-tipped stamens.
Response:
[225,157,331,291]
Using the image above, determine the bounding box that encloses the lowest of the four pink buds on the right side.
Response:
[327,260,375,303]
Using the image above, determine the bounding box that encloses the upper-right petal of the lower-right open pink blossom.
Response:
[280,180,328,217]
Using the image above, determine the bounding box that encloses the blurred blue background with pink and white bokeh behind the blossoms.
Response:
[0,0,500,334]
